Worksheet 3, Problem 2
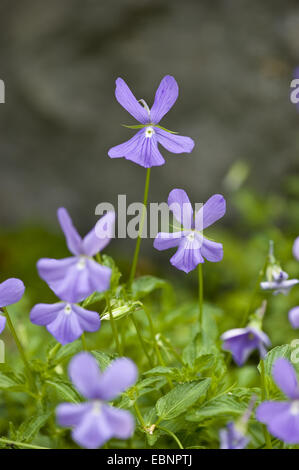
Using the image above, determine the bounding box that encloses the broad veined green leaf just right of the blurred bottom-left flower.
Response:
[156,379,211,421]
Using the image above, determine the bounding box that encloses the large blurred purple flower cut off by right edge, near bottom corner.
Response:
[256,358,299,444]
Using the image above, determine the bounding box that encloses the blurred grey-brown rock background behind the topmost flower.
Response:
[0,0,299,229]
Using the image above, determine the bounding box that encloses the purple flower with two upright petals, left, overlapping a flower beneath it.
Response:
[37,208,115,303]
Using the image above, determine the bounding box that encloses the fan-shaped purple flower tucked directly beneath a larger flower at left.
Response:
[30,302,101,345]
